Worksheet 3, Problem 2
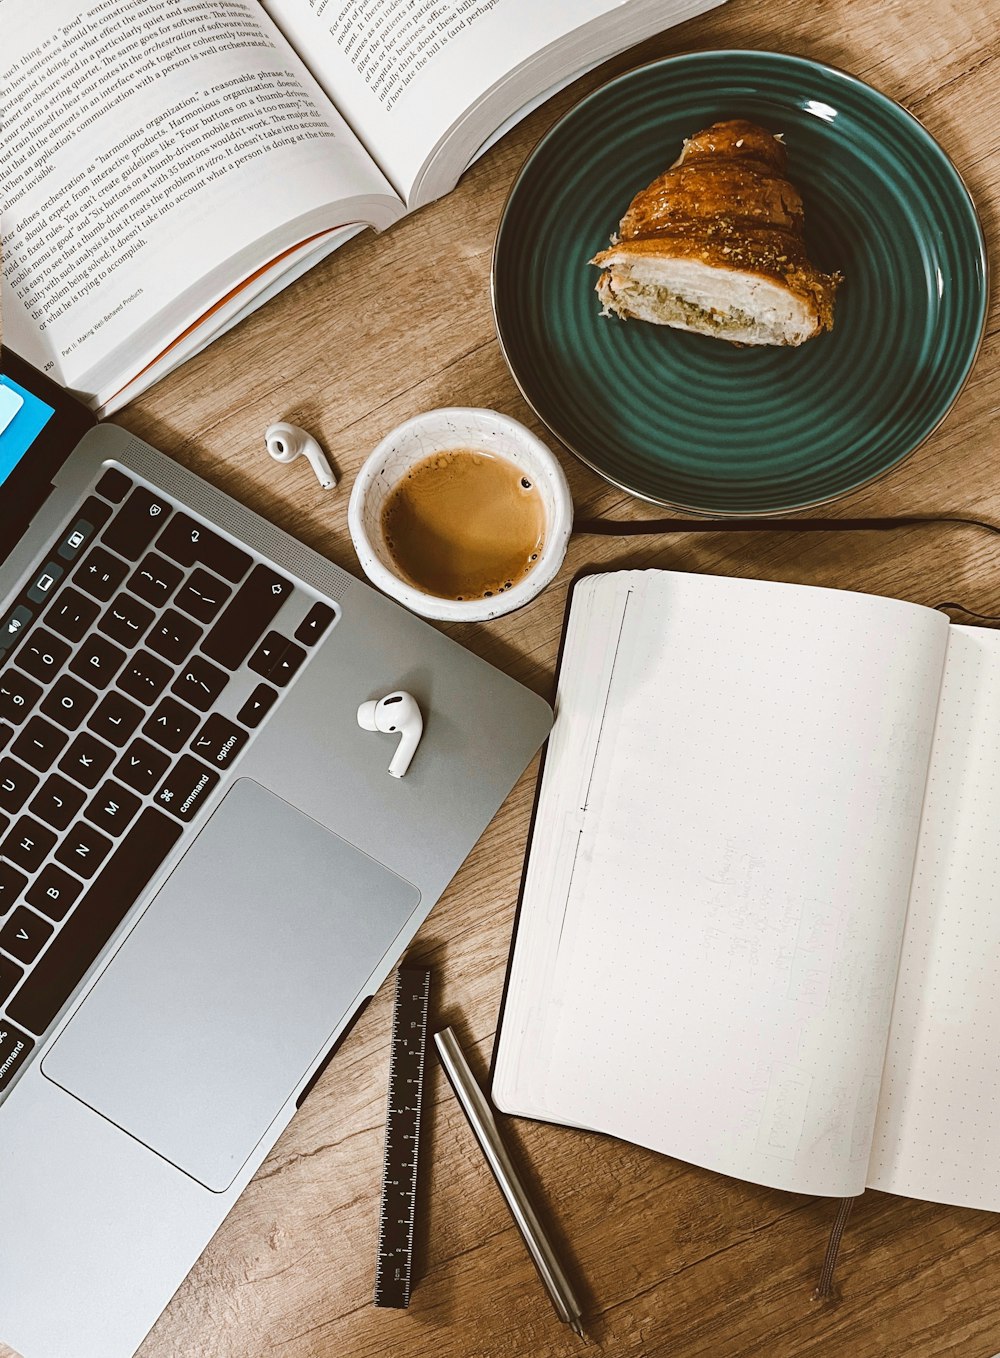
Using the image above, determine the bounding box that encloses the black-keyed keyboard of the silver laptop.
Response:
[0,469,334,1096]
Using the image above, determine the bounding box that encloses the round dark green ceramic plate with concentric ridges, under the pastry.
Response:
[493,52,988,515]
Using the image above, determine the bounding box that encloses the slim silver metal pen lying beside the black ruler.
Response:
[433,1028,584,1339]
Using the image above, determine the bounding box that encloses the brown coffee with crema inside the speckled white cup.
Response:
[382,448,545,600]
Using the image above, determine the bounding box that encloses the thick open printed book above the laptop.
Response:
[0,0,721,413]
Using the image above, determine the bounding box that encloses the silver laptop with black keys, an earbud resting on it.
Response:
[0,350,552,1358]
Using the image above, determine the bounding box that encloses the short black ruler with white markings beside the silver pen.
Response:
[375,967,431,1306]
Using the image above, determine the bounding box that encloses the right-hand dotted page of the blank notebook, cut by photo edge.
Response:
[868,627,1000,1211]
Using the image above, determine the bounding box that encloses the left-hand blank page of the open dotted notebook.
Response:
[493,572,948,1196]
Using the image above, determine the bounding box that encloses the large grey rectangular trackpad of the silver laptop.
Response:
[42,778,420,1192]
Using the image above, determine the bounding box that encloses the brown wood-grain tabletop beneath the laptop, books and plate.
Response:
[9,0,1000,1358]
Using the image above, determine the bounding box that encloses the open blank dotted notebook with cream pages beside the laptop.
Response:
[493,570,1000,1210]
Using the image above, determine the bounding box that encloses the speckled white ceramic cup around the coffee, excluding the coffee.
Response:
[348,406,573,622]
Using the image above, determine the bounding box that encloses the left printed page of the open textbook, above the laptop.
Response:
[0,0,402,395]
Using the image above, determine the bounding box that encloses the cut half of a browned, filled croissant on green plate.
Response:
[590,120,841,345]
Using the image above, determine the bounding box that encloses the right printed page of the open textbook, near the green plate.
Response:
[261,0,633,200]
